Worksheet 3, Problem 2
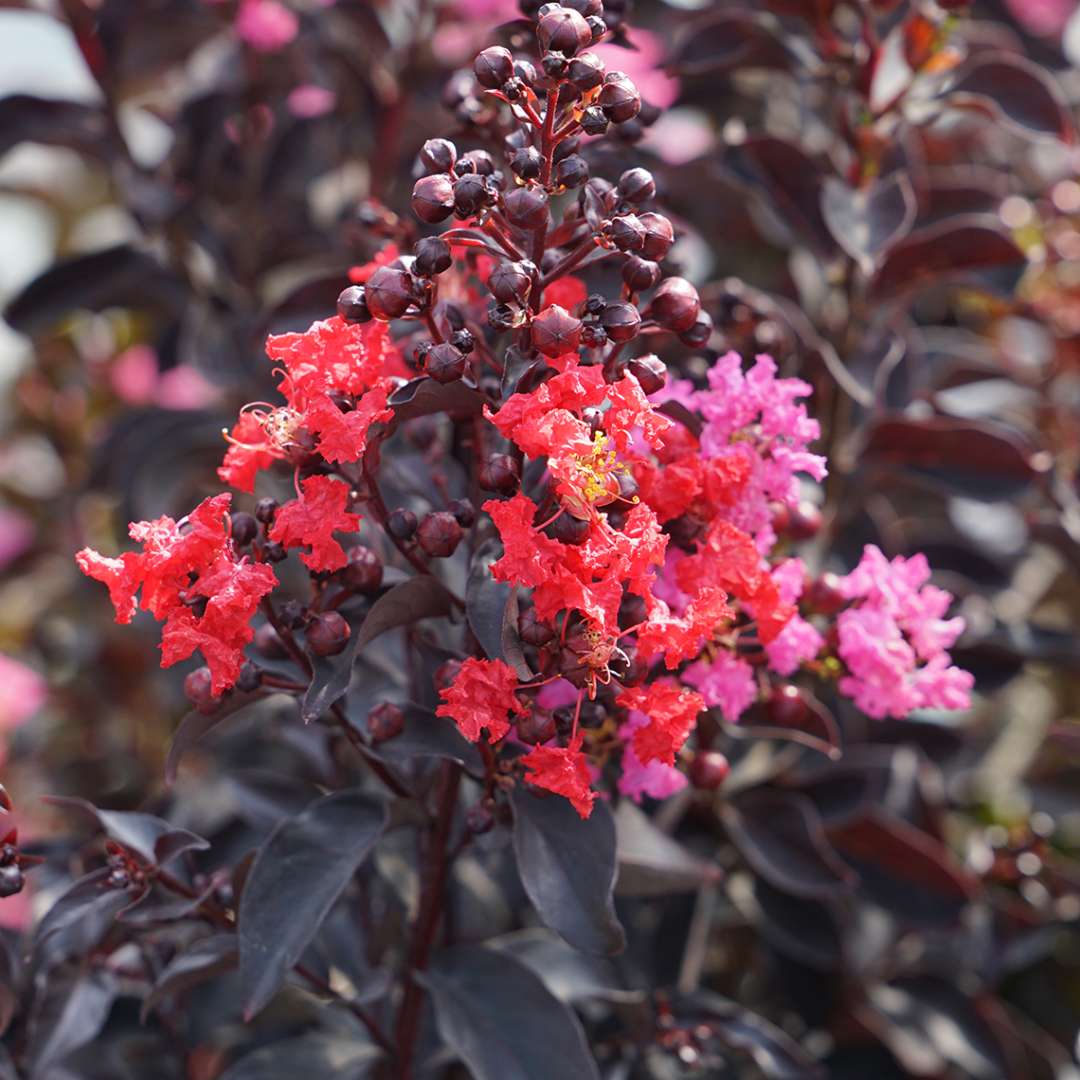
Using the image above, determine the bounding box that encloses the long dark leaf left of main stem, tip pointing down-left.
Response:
[239,791,387,1016]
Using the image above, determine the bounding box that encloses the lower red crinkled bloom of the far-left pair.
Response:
[161,555,278,694]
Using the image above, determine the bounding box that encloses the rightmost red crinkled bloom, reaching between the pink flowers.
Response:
[675,519,795,645]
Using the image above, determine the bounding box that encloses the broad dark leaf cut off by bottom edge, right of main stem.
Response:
[418,946,599,1080]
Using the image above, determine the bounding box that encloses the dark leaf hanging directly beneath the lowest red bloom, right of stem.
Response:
[511,786,626,955]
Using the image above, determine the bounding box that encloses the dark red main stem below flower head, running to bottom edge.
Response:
[394,761,461,1080]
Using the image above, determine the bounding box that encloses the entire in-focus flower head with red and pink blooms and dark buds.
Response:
[79,0,971,816]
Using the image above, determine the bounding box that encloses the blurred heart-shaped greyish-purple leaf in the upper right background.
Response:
[821,172,917,272]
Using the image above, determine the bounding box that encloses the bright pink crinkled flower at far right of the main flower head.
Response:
[836,544,974,718]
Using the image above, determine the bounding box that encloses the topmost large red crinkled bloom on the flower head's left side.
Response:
[267,315,408,413]
